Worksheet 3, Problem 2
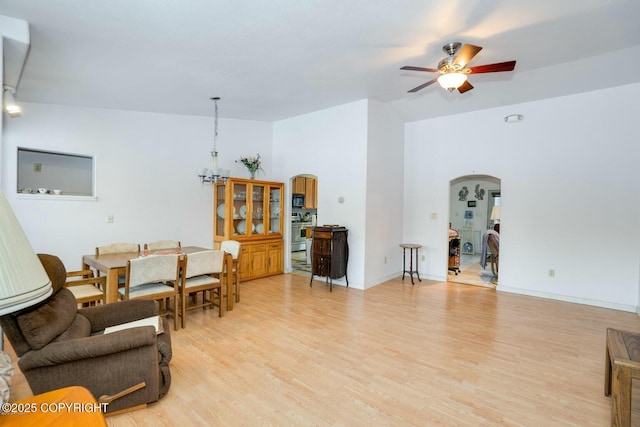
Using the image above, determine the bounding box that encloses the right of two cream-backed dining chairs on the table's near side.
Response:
[180,250,231,328]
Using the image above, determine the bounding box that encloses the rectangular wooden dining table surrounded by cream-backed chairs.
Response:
[82,246,233,311]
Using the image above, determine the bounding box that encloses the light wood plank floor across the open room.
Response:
[6,274,640,426]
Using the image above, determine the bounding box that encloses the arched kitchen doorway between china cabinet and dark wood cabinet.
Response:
[289,174,318,273]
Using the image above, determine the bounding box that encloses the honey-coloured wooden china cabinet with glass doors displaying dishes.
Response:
[213,178,284,281]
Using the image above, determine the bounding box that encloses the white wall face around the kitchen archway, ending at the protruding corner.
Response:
[273,100,368,289]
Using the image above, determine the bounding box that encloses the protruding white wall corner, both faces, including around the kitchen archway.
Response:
[273,100,403,289]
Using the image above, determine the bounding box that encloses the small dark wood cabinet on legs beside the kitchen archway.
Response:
[309,226,349,292]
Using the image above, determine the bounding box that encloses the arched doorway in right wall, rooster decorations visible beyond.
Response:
[448,175,502,288]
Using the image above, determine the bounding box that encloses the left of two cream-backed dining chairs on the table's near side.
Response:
[118,254,182,331]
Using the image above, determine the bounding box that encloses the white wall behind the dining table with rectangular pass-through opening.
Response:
[2,104,273,269]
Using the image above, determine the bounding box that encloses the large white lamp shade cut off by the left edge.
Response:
[0,190,52,315]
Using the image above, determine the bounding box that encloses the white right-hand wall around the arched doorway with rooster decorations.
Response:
[404,84,640,311]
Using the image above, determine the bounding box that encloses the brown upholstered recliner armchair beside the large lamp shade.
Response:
[0,254,171,412]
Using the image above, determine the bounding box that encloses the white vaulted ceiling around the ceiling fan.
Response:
[0,0,640,121]
